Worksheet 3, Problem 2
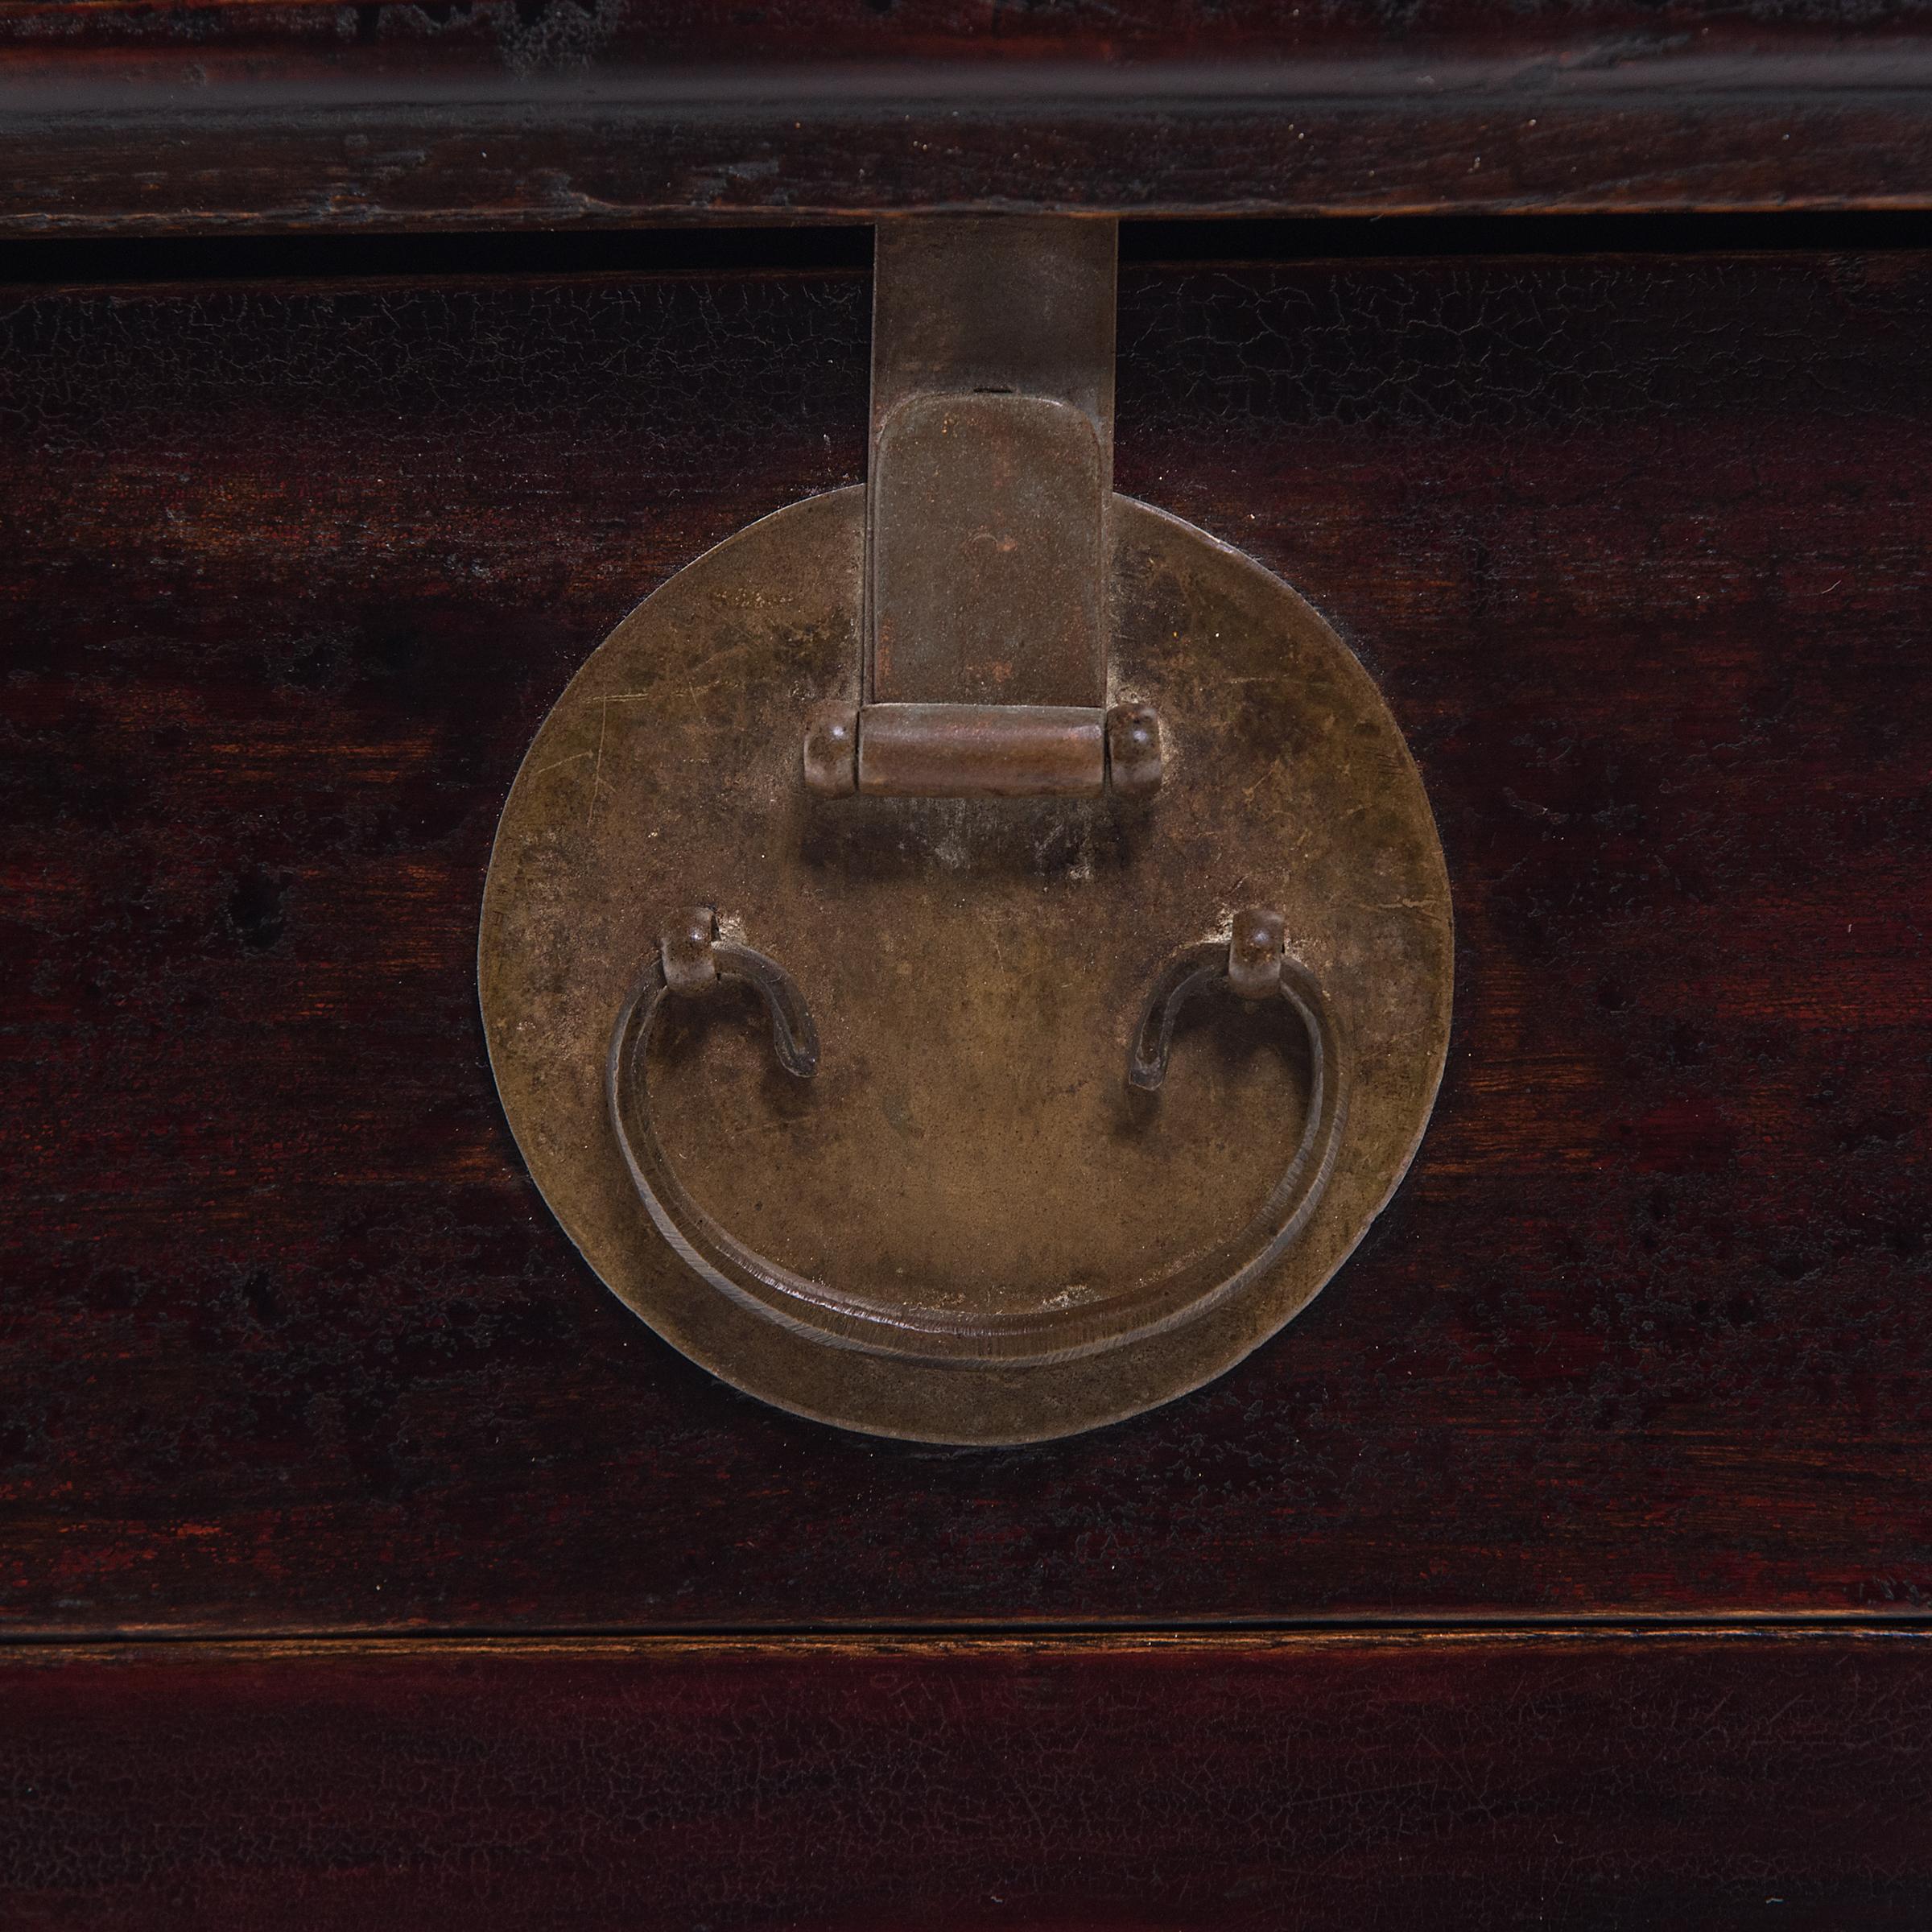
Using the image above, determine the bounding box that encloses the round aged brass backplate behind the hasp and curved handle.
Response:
[479,489,1453,1443]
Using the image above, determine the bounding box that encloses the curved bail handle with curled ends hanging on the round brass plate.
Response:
[605,906,1347,1366]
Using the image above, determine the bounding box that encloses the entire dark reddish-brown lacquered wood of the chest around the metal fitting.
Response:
[0,0,1932,1932]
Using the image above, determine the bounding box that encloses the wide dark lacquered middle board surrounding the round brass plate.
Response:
[0,237,1932,1633]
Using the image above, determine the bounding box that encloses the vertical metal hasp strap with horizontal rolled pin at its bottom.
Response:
[803,217,1161,798]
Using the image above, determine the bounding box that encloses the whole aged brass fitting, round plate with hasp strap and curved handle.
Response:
[479,218,1451,1443]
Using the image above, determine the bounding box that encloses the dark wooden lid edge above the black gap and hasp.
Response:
[0,0,1932,236]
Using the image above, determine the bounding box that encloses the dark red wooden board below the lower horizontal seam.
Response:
[0,1633,1932,1932]
